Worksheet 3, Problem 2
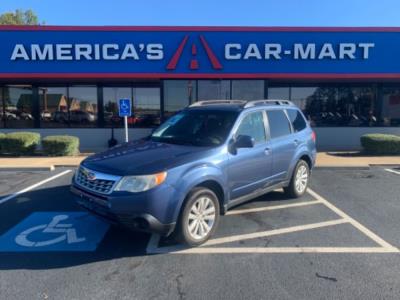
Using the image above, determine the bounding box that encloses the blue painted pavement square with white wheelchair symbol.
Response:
[0,212,109,252]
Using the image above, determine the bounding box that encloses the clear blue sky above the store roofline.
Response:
[0,0,400,26]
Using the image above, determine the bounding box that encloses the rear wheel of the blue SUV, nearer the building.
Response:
[284,160,310,198]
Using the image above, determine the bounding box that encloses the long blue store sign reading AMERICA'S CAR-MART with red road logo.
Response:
[0,27,400,78]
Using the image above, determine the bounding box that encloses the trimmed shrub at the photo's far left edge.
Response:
[0,131,40,155]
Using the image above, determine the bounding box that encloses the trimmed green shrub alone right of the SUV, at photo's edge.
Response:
[361,133,400,155]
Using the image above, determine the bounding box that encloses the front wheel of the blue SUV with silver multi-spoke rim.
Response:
[175,187,220,247]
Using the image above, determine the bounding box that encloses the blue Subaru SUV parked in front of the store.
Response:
[71,100,316,246]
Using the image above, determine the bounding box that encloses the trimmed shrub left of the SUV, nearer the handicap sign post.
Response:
[42,135,79,156]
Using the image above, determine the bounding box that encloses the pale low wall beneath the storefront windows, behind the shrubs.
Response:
[0,127,400,152]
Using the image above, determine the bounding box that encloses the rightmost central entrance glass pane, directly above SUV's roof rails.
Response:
[232,80,265,100]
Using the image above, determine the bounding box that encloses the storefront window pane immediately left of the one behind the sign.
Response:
[68,86,97,127]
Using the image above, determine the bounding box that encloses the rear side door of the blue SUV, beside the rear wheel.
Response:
[267,109,297,183]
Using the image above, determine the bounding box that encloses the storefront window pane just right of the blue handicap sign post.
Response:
[130,88,161,127]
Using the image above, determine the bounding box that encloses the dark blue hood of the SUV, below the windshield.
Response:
[82,140,215,176]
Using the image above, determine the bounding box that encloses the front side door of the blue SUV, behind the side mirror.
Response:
[228,110,272,199]
